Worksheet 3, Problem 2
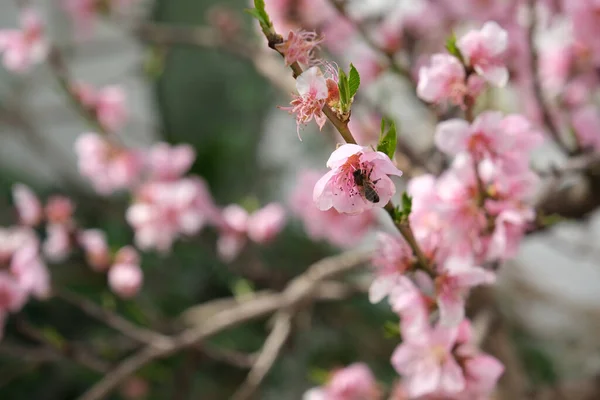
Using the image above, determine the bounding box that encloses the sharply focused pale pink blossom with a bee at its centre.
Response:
[313,144,402,214]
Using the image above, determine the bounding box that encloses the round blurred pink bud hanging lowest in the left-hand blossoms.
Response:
[108,246,144,299]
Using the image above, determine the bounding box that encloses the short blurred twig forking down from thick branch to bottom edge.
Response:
[232,311,292,400]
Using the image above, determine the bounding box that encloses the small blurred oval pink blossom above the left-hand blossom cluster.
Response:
[95,85,127,132]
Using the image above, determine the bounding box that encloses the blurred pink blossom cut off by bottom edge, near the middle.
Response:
[303,363,381,400]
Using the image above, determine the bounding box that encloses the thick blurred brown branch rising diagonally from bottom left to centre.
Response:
[79,251,371,400]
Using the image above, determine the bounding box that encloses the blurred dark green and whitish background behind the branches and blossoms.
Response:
[0,0,600,400]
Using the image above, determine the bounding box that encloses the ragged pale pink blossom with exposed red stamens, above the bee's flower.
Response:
[280,67,329,137]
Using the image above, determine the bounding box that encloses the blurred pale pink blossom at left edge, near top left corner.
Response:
[0,9,50,72]
